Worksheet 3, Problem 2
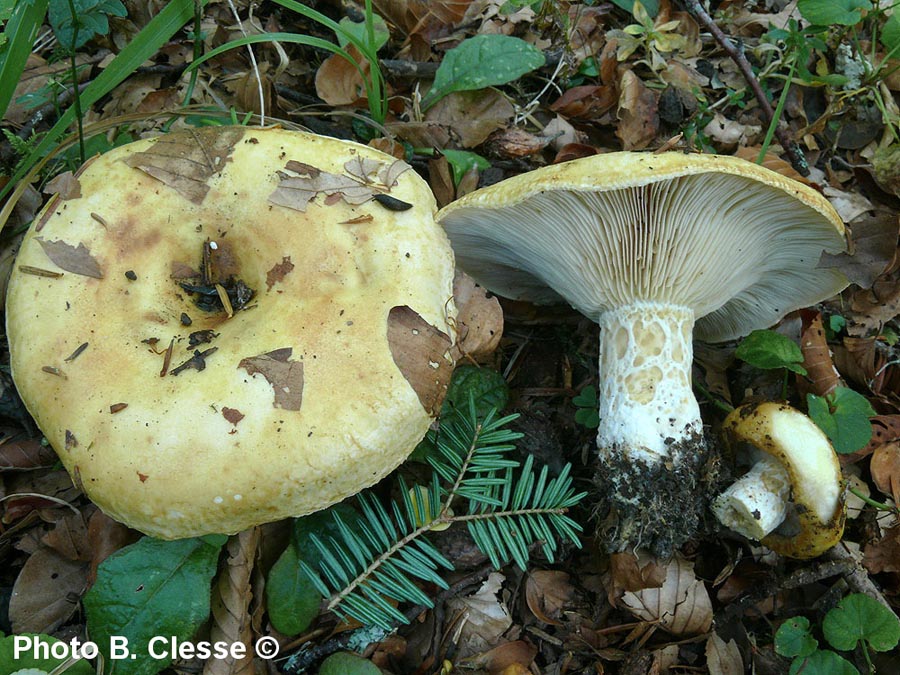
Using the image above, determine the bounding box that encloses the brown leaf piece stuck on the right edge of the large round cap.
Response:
[387,305,453,417]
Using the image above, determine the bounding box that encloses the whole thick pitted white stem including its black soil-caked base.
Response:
[597,302,706,557]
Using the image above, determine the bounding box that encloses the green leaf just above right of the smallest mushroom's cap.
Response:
[806,387,875,455]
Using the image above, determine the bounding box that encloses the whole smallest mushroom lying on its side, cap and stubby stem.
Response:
[712,403,846,558]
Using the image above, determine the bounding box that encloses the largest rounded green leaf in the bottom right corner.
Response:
[822,593,900,652]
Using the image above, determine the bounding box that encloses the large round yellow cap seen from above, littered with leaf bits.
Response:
[6,127,455,539]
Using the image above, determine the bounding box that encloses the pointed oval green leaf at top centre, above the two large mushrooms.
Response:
[421,35,544,111]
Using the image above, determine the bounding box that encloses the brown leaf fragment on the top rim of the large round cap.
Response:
[124,126,246,204]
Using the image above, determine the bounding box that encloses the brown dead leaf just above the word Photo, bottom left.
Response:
[9,548,88,633]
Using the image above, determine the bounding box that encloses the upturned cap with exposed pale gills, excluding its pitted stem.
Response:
[438,152,847,342]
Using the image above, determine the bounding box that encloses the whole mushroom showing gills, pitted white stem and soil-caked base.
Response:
[438,152,847,555]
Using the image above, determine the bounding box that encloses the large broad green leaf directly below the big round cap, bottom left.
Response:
[84,537,220,675]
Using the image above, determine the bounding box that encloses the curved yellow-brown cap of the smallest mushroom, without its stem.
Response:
[722,403,846,558]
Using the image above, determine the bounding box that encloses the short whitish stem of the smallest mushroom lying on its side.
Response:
[711,455,791,540]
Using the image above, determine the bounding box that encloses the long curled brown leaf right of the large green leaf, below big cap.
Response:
[203,527,259,675]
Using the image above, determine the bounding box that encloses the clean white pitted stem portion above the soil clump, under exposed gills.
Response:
[597,302,703,463]
